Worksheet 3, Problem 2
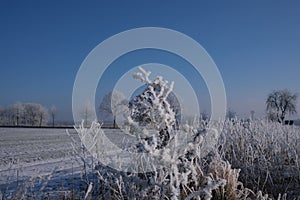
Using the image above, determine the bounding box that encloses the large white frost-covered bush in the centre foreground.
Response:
[78,68,234,199]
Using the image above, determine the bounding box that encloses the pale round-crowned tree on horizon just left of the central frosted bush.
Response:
[99,90,128,128]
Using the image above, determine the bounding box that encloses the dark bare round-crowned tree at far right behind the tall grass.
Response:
[266,89,297,123]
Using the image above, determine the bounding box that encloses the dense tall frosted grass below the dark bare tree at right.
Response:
[219,120,300,198]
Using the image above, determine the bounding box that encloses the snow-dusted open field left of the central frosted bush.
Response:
[0,128,130,199]
